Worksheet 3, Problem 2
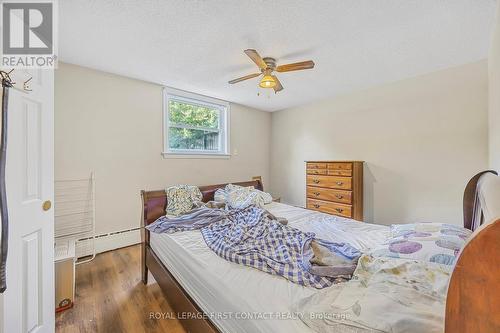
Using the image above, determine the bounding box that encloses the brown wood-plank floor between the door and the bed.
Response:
[56,245,185,333]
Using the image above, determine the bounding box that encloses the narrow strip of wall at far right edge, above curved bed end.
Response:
[488,3,500,171]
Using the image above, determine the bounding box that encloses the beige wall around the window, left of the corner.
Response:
[55,63,271,233]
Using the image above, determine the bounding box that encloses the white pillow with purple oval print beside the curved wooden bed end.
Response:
[369,223,472,265]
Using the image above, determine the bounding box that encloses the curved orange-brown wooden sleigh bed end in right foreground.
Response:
[445,171,500,333]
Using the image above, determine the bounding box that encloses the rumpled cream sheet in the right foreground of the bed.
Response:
[295,255,452,333]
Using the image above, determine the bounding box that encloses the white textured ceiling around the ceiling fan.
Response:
[59,0,496,111]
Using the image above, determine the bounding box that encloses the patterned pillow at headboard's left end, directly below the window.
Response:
[165,185,203,216]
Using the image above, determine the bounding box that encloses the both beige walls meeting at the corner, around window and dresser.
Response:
[55,61,488,233]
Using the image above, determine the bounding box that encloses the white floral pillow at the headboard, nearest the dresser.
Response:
[214,184,273,209]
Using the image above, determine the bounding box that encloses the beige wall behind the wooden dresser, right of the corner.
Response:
[271,61,488,224]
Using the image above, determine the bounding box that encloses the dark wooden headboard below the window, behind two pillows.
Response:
[141,177,264,226]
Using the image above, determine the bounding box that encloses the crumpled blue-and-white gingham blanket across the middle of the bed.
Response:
[147,206,360,289]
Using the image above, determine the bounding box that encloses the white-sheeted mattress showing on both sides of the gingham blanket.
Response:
[150,202,389,333]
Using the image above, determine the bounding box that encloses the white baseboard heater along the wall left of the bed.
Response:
[75,227,141,258]
